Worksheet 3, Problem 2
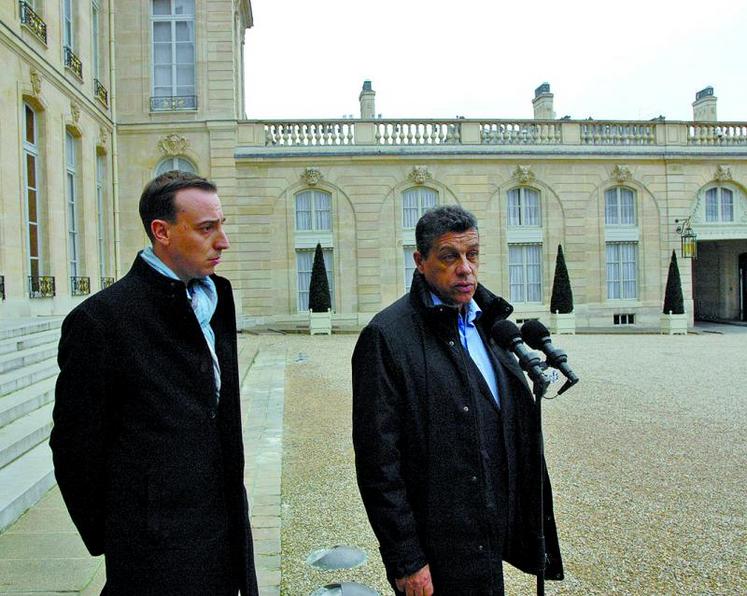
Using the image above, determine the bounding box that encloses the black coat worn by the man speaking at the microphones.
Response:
[352,272,563,595]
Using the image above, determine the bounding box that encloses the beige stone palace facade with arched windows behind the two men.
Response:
[0,0,747,329]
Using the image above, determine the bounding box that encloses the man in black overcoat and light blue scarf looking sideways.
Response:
[50,172,258,596]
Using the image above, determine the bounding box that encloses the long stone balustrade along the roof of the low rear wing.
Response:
[248,118,747,152]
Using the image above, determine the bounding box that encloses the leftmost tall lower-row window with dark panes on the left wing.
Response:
[23,103,42,277]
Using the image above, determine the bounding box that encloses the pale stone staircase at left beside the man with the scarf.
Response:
[0,318,62,532]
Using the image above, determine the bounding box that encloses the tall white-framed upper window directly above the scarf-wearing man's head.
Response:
[151,0,197,110]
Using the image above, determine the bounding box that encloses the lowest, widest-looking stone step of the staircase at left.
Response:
[0,441,55,532]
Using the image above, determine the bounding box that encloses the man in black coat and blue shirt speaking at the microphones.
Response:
[352,206,563,596]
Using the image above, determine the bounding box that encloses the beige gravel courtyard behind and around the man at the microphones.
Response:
[266,333,747,596]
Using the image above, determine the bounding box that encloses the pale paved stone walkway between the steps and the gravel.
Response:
[0,336,286,596]
